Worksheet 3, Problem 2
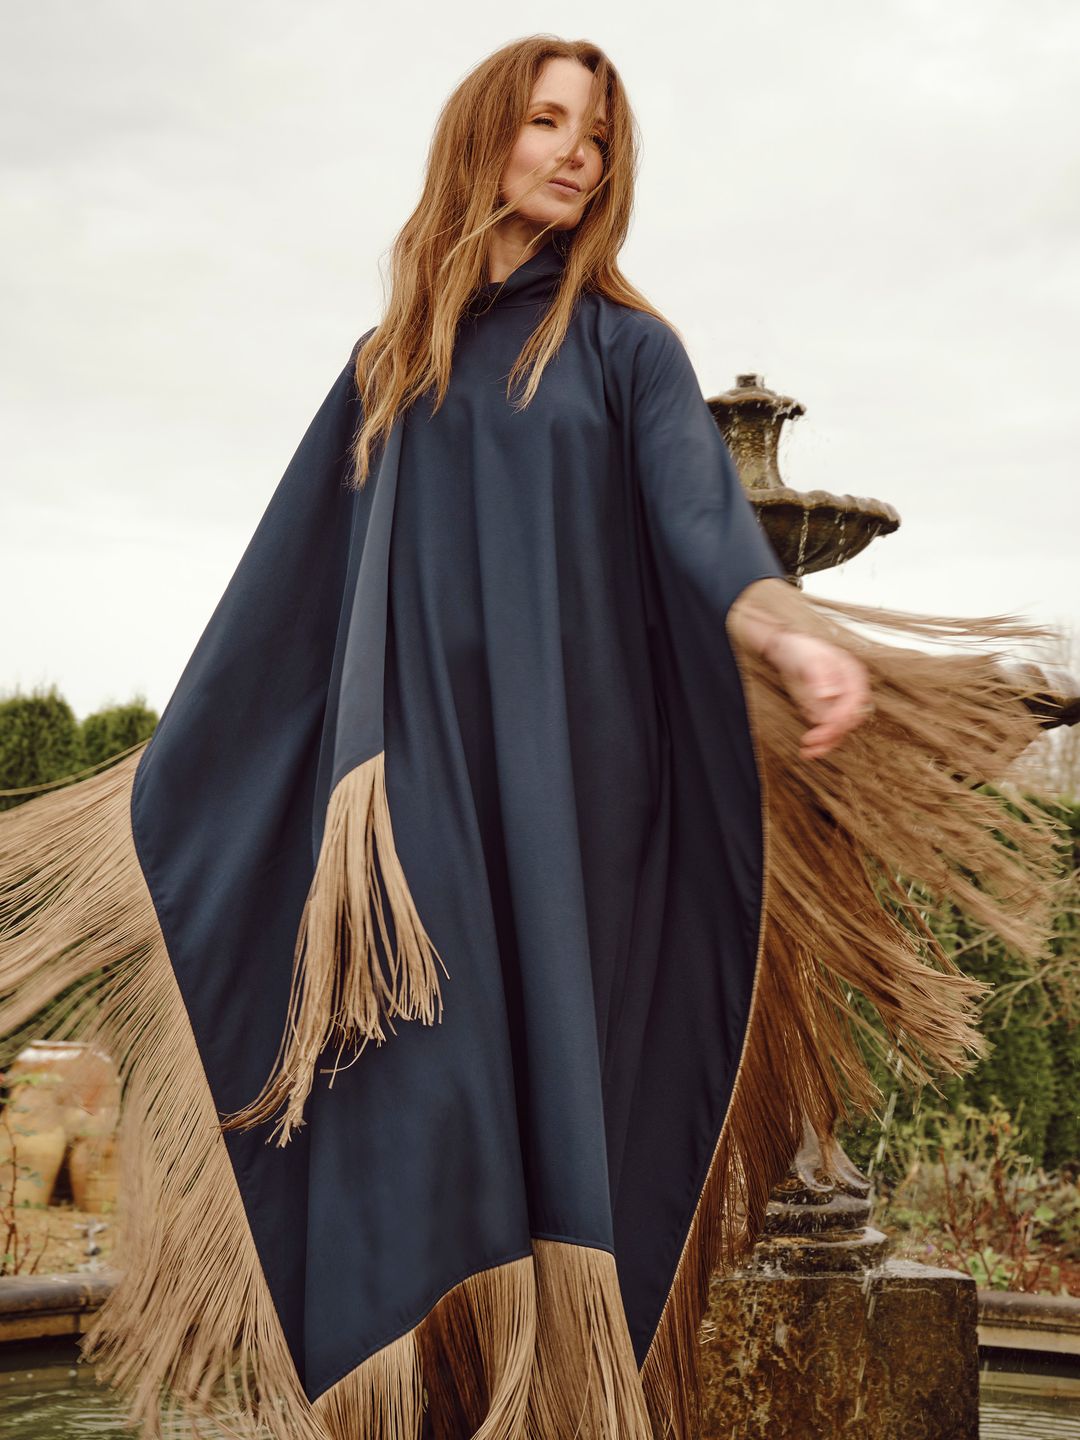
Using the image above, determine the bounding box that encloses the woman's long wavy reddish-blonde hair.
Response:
[353,35,670,488]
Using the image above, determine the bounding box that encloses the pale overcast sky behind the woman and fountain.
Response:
[0,0,1080,714]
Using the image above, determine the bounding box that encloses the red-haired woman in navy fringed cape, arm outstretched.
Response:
[0,36,1051,1440]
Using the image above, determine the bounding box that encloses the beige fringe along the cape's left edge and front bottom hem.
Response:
[0,752,651,1440]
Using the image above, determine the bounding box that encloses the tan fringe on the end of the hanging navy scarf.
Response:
[222,752,449,1145]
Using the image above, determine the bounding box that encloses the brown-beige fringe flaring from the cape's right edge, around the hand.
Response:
[641,586,1066,1440]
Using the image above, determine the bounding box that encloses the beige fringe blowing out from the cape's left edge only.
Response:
[0,752,327,1440]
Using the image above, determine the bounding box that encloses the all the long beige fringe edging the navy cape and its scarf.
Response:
[0,595,1066,1440]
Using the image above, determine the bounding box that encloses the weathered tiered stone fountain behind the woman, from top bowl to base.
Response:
[701,374,1080,1440]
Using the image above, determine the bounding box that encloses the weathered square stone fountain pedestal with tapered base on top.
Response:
[701,1136,979,1440]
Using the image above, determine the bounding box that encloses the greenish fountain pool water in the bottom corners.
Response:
[0,1341,1080,1440]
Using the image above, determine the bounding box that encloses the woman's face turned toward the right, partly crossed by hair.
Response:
[500,58,606,230]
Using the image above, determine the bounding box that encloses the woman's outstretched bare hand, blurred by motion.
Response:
[763,629,874,760]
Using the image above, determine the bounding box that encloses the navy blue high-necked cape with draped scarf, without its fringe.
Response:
[132,238,783,1400]
